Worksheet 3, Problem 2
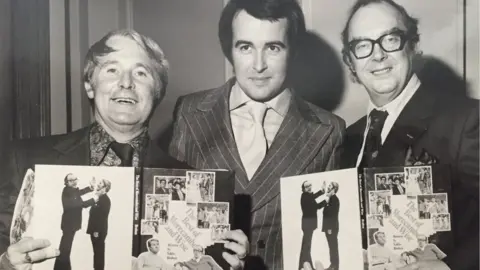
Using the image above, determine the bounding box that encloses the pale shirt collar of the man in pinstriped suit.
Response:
[229,83,292,117]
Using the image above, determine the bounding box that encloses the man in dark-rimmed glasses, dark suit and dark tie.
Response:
[342,0,479,269]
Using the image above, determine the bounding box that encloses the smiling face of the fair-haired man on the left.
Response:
[85,36,160,134]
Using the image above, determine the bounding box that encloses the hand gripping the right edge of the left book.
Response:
[221,230,250,270]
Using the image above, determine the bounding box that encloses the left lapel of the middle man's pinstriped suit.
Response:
[180,80,248,190]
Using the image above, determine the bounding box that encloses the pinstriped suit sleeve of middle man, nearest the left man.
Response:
[168,97,187,162]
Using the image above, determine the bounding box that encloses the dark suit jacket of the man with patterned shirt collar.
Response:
[0,127,190,253]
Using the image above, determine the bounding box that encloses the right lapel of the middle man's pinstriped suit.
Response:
[247,95,333,211]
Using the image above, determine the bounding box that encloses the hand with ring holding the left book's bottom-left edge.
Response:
[0,237,60,270]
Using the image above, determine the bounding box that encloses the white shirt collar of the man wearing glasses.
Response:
[367,73,421,115]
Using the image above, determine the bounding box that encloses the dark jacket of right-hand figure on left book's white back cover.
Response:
[87,194,111,236]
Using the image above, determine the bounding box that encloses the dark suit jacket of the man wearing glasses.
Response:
[345,85,479,269]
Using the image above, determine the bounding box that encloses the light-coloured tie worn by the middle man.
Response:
[241,101,267,180]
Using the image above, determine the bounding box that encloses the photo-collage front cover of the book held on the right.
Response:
[363,165,453,270]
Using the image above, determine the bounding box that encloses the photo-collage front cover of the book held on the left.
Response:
[133,168,233,270]
